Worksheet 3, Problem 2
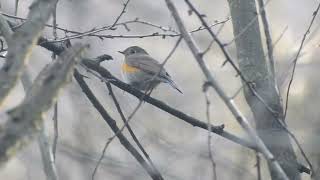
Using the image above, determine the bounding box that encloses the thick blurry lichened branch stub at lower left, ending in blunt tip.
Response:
[0,44,84,166]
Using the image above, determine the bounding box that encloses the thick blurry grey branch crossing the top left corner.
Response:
[0,0,57,105]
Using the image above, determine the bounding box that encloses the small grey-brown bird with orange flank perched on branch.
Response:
[118,46,182,94]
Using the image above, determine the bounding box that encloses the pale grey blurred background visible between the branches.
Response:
[0,0,320,180]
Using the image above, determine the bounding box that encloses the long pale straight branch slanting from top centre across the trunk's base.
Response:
[165,0,288,180]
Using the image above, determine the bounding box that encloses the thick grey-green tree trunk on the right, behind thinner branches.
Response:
[228,0,300,180]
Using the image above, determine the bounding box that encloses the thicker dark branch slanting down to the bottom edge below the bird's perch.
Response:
[74,70,163,180]
